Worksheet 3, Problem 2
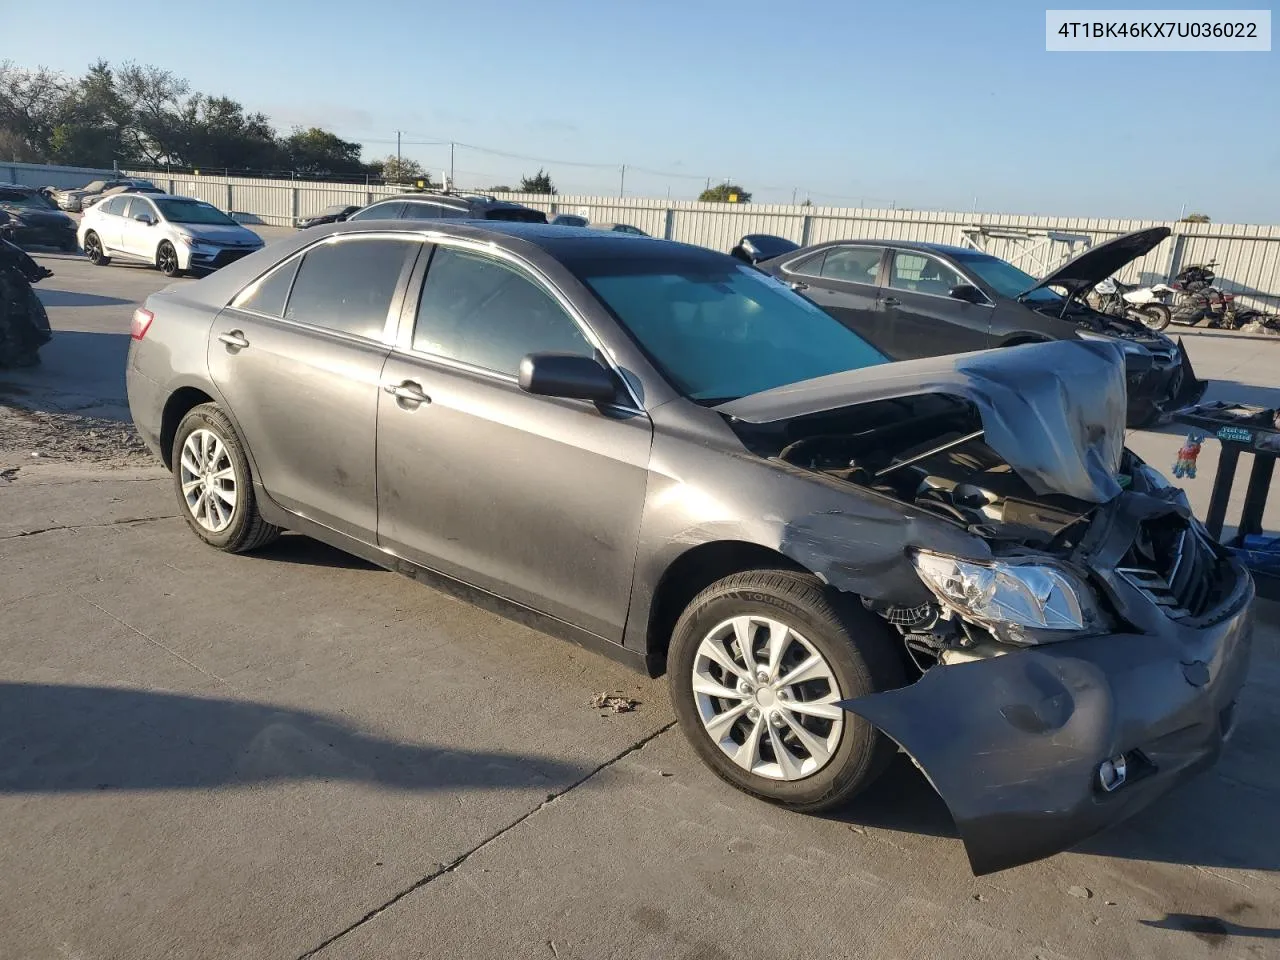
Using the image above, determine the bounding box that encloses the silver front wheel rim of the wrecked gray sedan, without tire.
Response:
[692,614,845,781]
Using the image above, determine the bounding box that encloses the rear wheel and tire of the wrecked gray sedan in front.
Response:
[173,403,280,553]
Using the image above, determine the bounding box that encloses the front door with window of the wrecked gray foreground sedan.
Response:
[378,244,652,640]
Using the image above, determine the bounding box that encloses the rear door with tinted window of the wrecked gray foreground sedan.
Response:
[209,234,422,543]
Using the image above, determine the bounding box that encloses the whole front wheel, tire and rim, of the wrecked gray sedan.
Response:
[667,570,905,813]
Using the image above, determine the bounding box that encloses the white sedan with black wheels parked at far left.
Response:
[78,193,262,276]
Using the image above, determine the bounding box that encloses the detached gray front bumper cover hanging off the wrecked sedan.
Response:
[841,568,1253,876]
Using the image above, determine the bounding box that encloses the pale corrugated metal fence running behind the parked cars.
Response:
[0,164,1280,310]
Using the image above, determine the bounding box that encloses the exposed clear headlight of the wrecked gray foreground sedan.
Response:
[913,550,1107,646]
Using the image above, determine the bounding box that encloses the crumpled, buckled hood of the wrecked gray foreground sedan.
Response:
[716,340,1126,503]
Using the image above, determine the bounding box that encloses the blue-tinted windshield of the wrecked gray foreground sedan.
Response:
[568,259,886,406]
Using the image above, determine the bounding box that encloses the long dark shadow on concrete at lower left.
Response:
[0,682,588,795]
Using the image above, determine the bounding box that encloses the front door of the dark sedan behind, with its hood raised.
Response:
[881,250,992,360]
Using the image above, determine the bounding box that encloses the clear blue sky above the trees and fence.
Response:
[12,0,1280,223]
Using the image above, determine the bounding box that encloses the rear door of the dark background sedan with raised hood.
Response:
[786,243,892,356]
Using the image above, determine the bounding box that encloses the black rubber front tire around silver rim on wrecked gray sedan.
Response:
[667,575,893,812]
